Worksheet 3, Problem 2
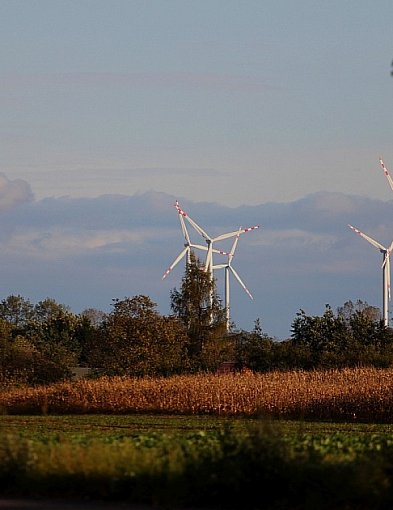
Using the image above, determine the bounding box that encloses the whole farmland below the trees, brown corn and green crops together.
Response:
[0,369,393,510]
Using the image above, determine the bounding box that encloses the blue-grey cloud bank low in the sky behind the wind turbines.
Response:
[0,185,393,338]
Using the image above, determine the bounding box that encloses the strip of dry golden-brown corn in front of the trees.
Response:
[0,368,393,422]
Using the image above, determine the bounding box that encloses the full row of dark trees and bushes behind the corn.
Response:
[0,256,393,384]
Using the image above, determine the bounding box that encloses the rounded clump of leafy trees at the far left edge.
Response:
[0,295,86,384]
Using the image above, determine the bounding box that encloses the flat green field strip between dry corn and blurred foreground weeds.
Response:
[0,414,393,462]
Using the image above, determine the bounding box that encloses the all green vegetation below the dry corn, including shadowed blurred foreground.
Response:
[0,416,393,510]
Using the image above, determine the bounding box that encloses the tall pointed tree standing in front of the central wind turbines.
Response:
[170,252,226,368]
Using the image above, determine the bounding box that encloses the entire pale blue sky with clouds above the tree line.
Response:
[0,0,393,338]
